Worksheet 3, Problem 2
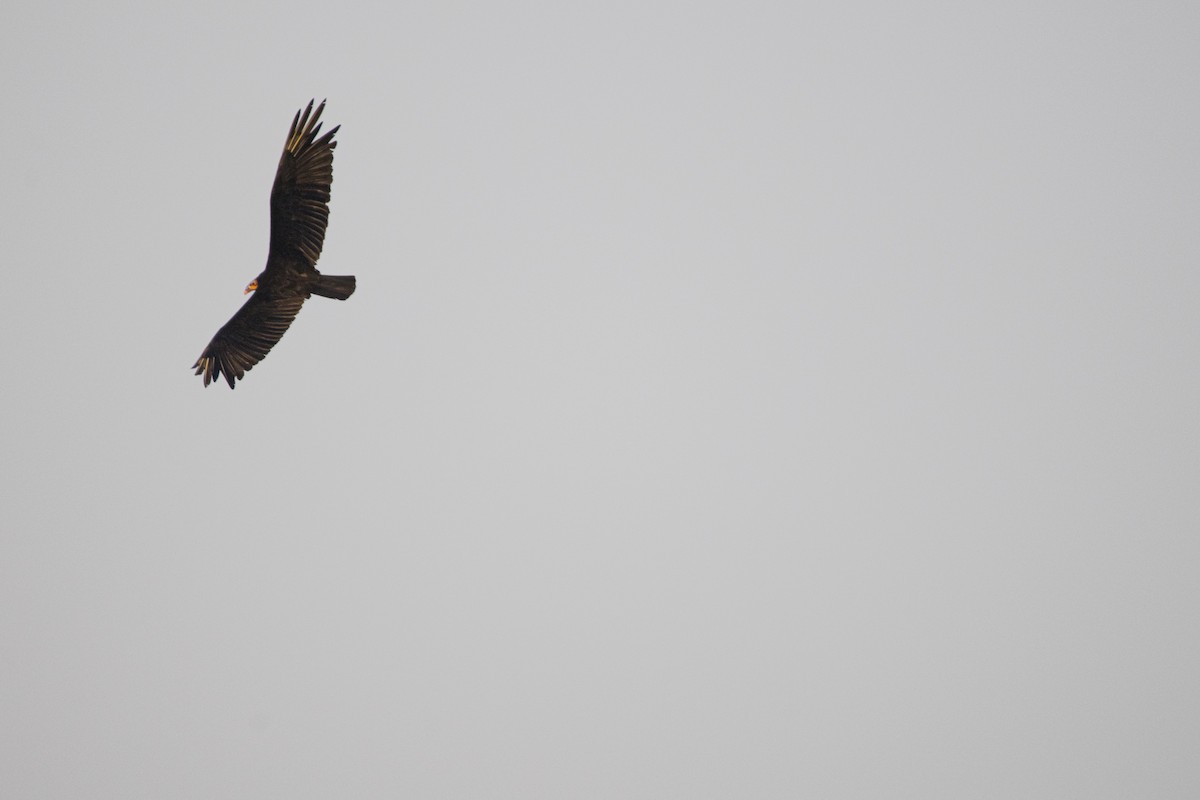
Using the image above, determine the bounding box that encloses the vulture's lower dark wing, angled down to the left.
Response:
[192,291,305,389]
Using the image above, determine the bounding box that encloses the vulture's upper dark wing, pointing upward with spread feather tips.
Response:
[266,101,341,272]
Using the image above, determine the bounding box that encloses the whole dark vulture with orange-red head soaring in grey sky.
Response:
[192,101,354,389]
